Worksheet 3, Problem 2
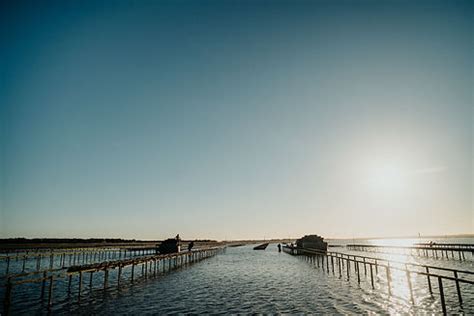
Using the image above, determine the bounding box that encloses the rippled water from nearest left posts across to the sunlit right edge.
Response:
[0,239,474,314]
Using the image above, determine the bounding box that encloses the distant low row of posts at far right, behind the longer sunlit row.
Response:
[347,244,474,261]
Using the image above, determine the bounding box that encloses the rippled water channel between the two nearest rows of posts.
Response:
[64,245,384,314]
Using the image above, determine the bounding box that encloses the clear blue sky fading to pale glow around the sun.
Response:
[0,0,474,240]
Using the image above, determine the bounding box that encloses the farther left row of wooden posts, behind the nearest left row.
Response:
[0,248,156,276]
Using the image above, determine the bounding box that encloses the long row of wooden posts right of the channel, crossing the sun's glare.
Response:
[283,247,474,314]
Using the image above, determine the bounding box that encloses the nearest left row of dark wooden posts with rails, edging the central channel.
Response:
[3,248,222,315]
